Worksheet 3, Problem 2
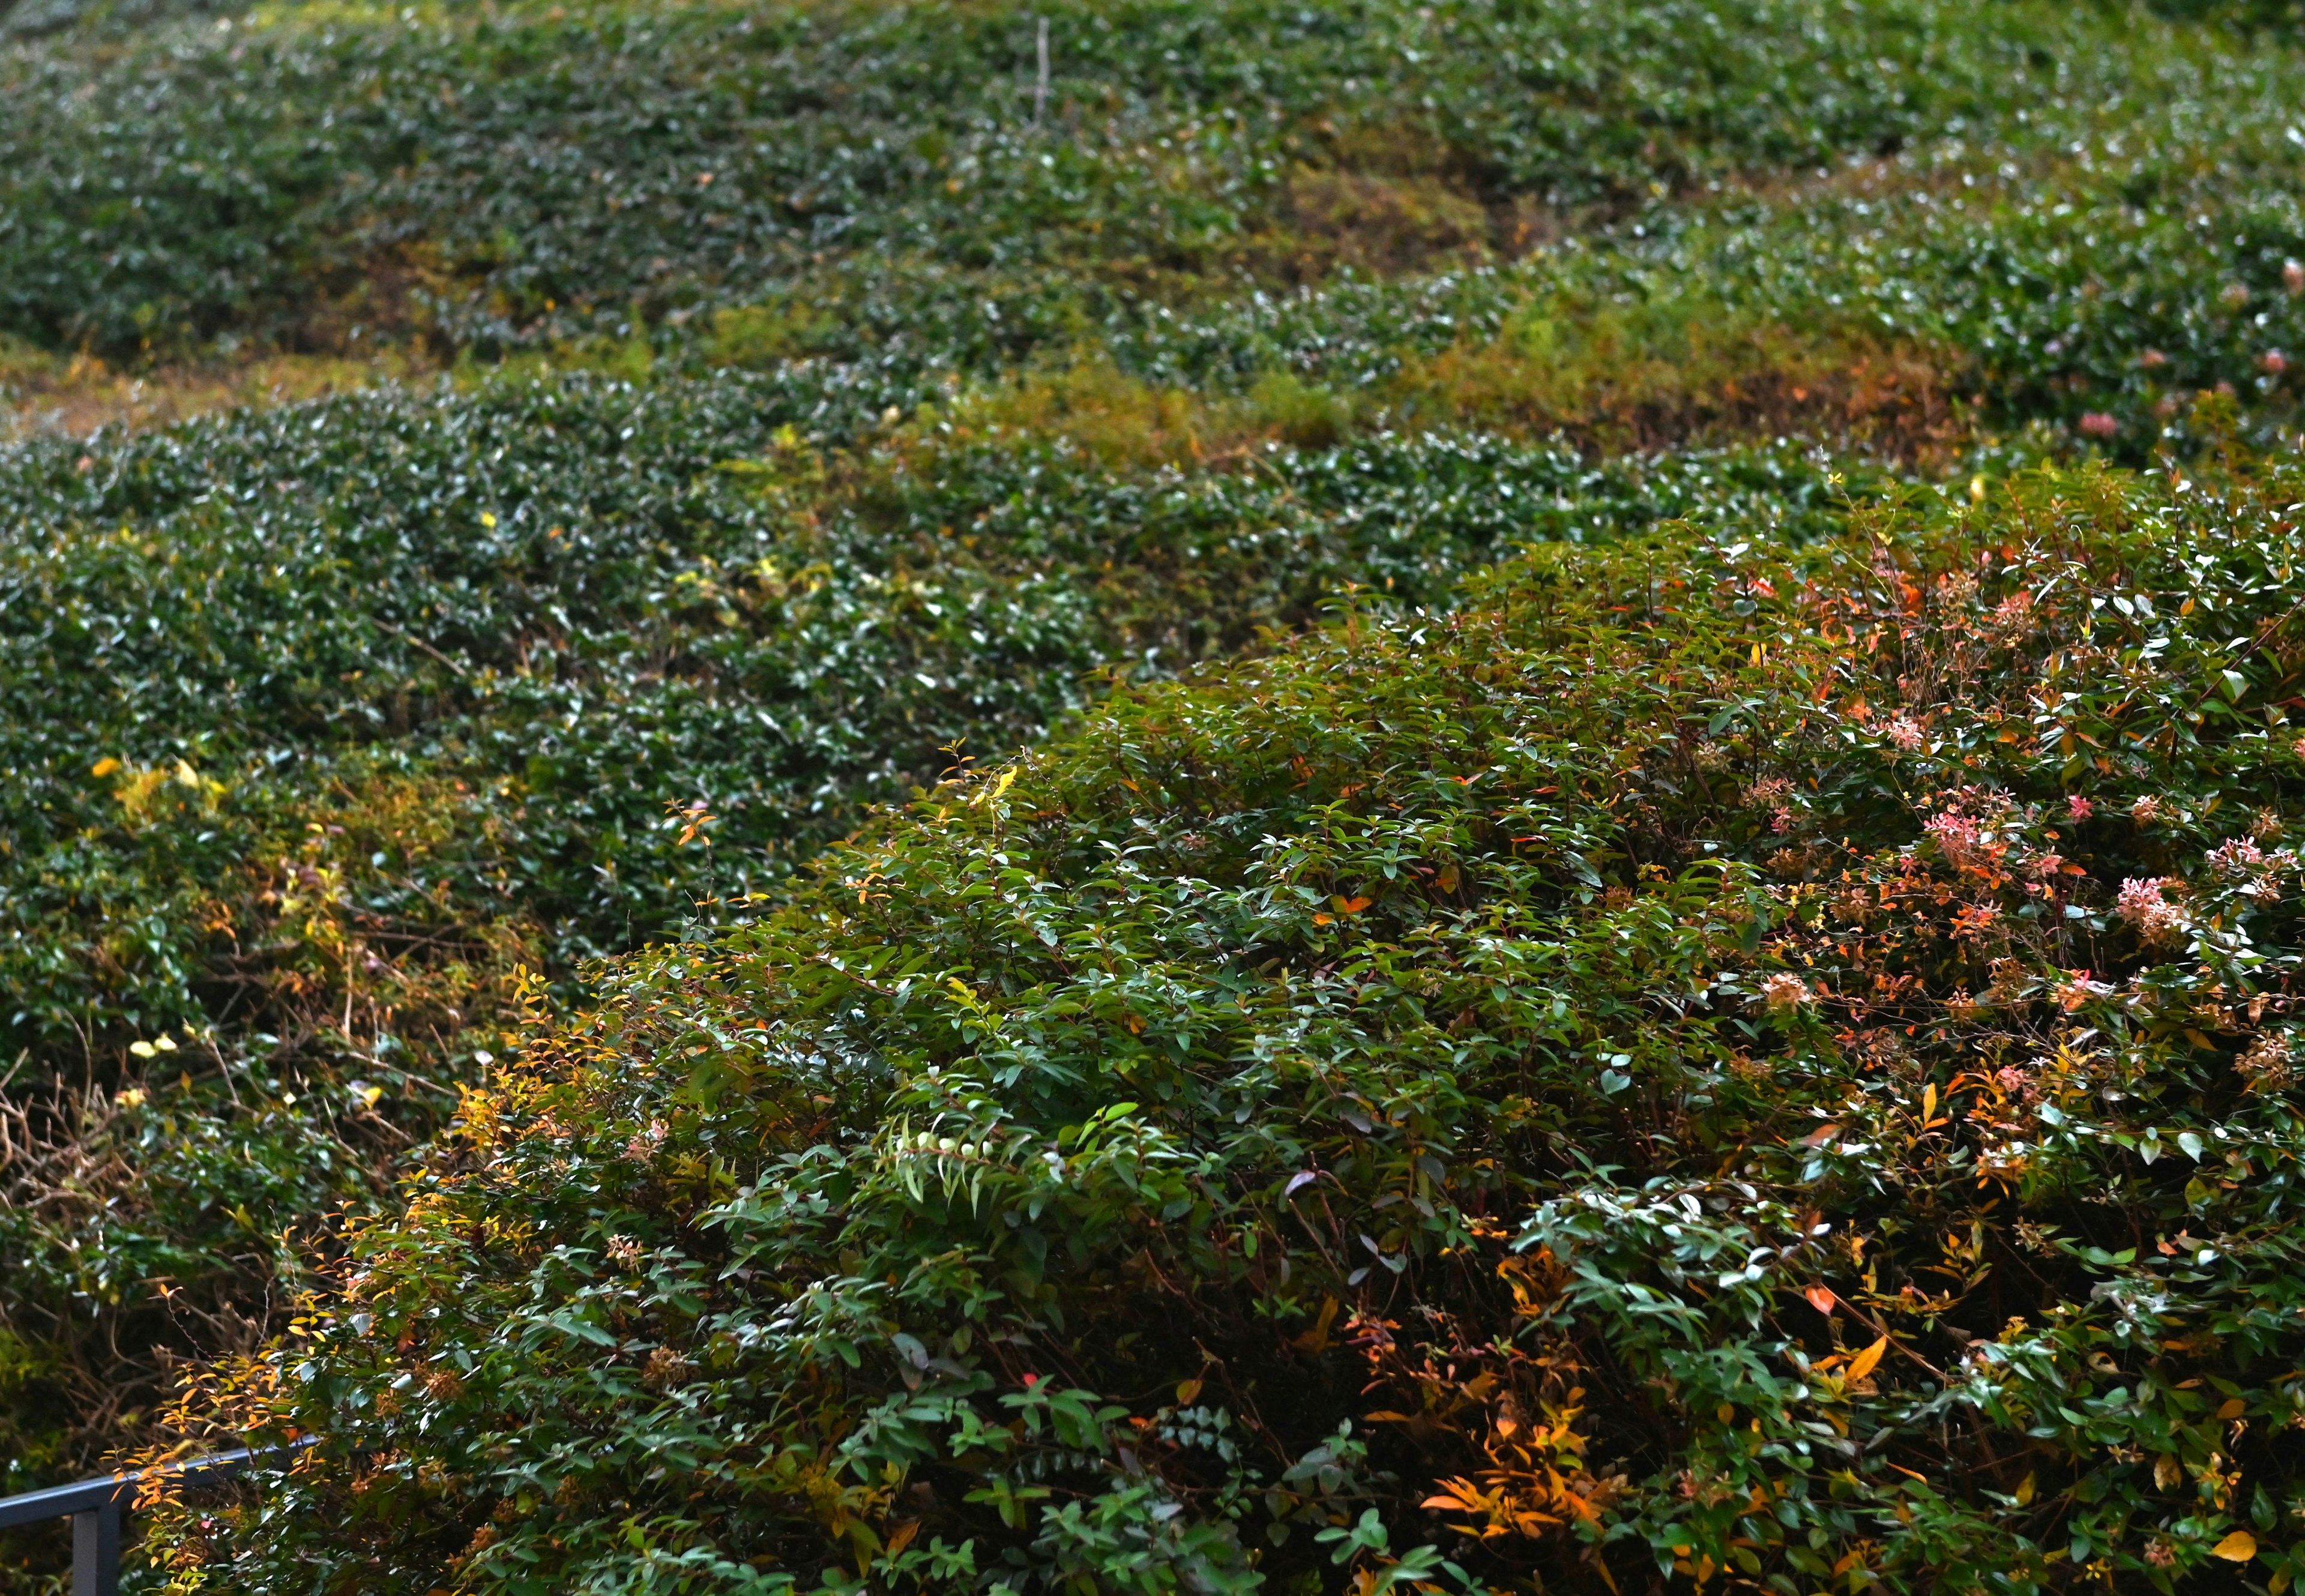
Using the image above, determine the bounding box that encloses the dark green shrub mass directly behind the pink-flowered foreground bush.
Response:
[0,352,1853,1513]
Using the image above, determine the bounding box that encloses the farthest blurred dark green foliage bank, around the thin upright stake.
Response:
[0,0,2088,364]
